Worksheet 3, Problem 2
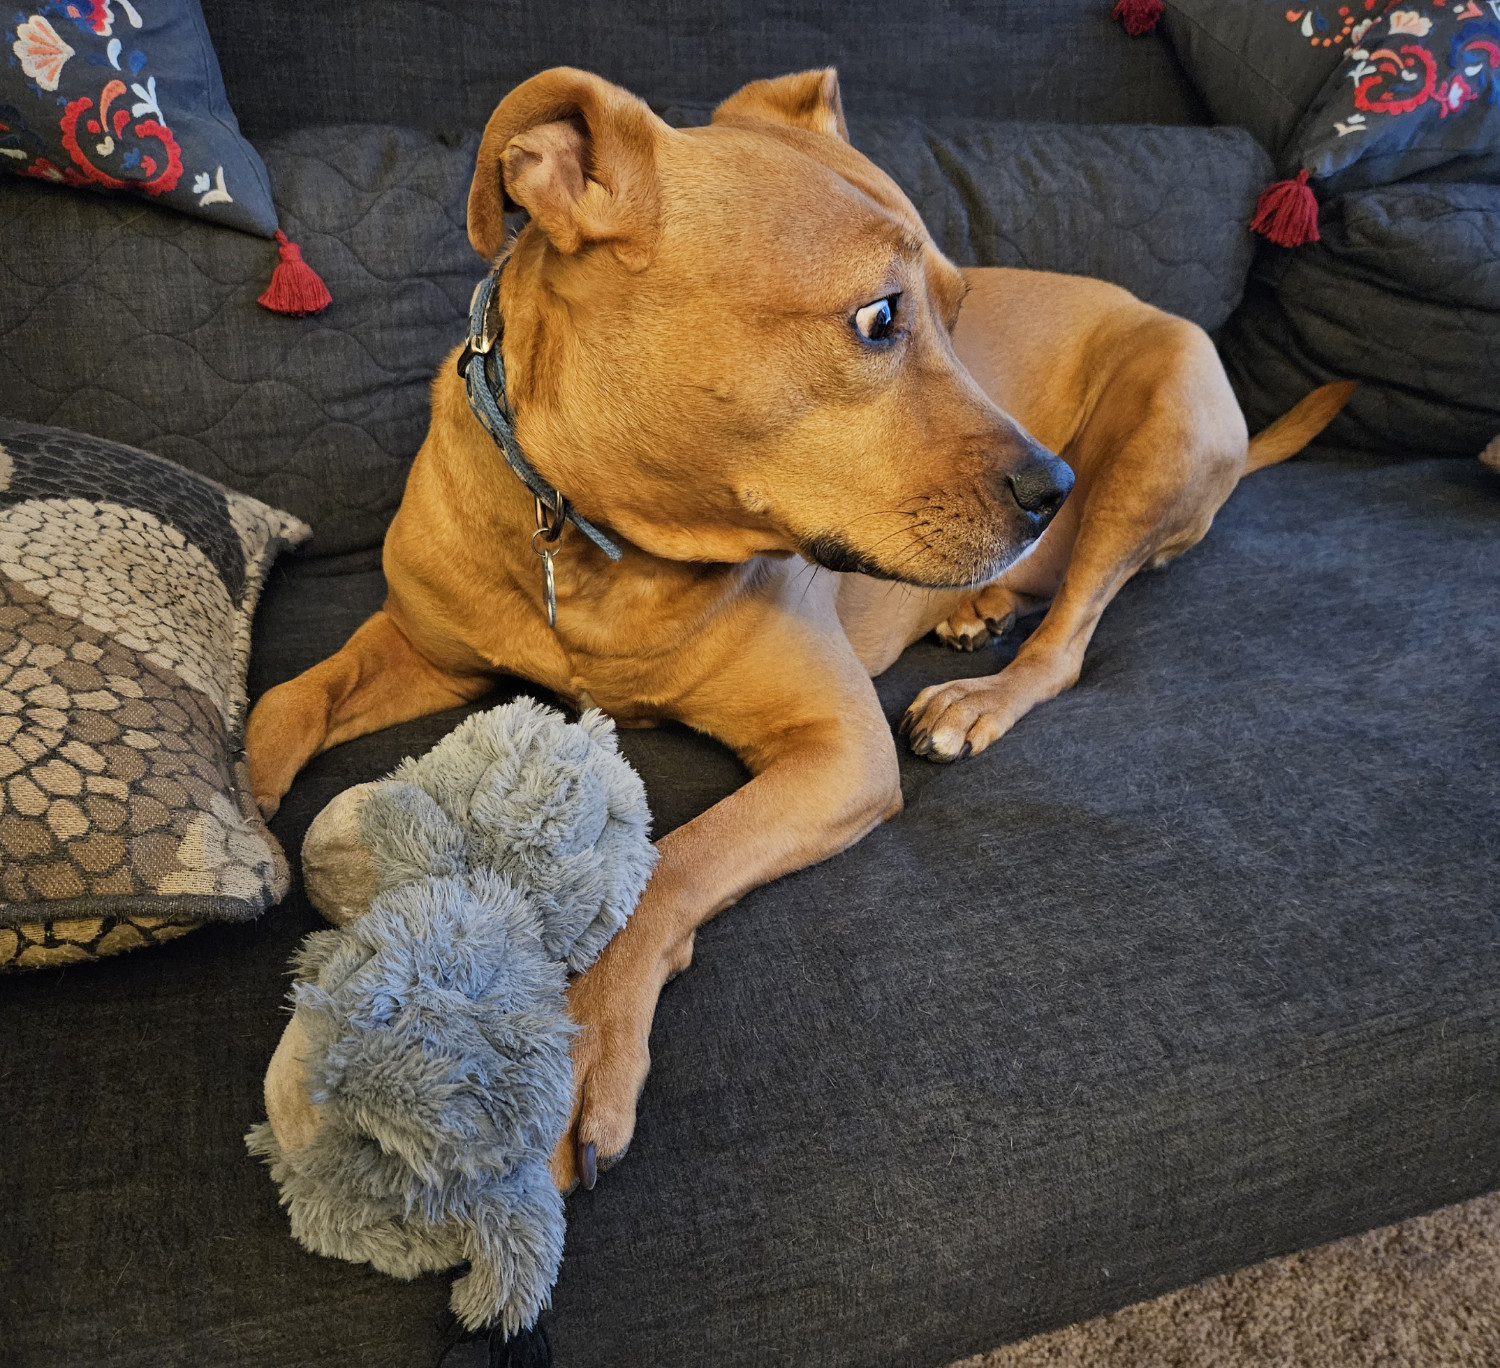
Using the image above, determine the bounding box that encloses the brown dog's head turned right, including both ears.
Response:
[468,68,1073,585]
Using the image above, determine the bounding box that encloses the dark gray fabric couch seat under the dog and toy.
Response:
[0,459,1500,1368]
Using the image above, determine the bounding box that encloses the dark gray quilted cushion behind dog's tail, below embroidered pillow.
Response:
[1221,185,1500,456]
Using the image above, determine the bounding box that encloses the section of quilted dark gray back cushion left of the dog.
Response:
[0,128,480,552]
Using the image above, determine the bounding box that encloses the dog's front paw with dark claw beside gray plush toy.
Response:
[552,951,660,1193]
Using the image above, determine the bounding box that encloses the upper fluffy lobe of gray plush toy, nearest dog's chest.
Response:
[302,698,656,974]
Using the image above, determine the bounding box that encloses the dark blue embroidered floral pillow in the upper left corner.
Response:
[0,0,276,237]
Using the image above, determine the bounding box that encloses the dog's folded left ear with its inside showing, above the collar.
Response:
[468,66,666,270]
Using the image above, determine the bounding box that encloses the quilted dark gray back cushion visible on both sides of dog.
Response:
[0,119,1266,555]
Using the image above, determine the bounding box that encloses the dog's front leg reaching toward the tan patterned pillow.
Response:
[245,611,491,818]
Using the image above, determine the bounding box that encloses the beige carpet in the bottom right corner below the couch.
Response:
[953,1193,1500,1368]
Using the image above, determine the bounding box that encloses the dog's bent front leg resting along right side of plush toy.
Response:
[552,636,902,1193]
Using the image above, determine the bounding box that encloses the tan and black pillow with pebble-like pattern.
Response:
[0,419,309,972]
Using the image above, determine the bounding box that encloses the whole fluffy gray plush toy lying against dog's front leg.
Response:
[246,699,656,1335]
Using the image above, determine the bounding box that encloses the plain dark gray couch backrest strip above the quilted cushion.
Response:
[203,0,1208,138]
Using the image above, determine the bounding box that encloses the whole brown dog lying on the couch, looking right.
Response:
[248,69,1347,1188]
